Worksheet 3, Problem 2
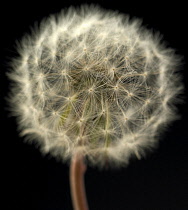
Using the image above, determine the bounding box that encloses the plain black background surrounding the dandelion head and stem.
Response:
[0,0,188,210]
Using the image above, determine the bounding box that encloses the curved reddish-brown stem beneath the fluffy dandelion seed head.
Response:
[70,154,89,210]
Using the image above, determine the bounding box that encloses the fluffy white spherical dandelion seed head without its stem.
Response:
[9,5,181,166]
